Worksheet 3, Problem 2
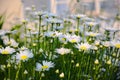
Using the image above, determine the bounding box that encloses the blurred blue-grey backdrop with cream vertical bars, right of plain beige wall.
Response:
[22,0,120,17]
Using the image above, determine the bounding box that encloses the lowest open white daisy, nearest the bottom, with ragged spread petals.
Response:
[36,61,54,71]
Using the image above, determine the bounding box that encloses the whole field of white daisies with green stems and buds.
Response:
[0,9,120,80]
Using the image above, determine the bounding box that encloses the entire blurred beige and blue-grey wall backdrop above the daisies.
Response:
[0,0,120,29]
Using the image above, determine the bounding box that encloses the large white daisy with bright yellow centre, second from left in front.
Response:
[16,50,33,61]
